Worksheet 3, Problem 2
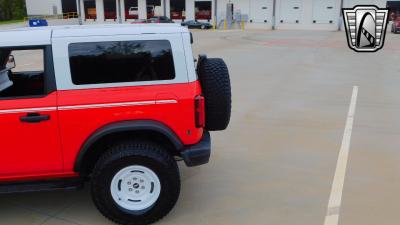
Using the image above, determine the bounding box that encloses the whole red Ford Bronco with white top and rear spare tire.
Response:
[0,24,231,224]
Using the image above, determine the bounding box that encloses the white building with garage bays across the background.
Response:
[26,0,400,30]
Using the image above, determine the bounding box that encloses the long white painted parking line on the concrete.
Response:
[324,86,358,225]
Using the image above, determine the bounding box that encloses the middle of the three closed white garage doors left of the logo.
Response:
[280,0,302,23]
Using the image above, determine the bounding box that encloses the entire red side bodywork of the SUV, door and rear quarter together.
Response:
[0,82,203,182]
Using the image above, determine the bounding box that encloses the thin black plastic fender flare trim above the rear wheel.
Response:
[74,120,184,173]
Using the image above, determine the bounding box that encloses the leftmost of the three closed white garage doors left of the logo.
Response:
[249,0,273,23]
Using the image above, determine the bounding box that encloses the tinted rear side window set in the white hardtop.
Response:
[69,40,175,85]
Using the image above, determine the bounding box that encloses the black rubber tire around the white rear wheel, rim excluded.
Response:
[91,141,180,225]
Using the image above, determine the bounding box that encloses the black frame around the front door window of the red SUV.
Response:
[0,45,57,101]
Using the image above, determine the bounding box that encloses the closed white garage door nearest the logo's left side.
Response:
[313,0,339,23]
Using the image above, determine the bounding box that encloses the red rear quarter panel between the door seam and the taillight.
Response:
[58,82,203,172]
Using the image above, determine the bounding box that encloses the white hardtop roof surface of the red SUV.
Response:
[0,24,189,48]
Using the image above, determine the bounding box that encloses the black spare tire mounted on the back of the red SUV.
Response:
[197,56,232,131]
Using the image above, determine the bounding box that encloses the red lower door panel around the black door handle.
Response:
[0,92,63,180]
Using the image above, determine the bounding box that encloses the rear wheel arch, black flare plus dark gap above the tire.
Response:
[74,120,183,176]
